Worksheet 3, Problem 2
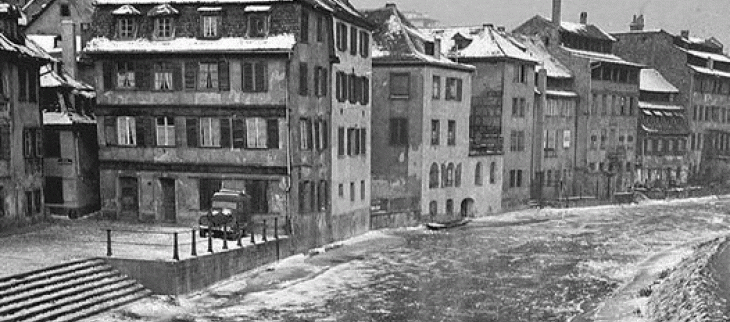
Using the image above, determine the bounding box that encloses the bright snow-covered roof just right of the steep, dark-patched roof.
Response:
[425,26,538,63]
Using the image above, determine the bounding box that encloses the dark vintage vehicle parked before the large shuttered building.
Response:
[198,189,253,239]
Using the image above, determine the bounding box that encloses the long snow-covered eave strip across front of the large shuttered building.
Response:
[84,34,296,54]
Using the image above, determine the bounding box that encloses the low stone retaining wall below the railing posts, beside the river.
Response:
[102,238,290,295]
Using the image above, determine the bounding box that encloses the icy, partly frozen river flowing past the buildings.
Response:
[94,197,730,322]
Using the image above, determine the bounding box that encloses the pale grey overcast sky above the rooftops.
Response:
[350,0,730,51]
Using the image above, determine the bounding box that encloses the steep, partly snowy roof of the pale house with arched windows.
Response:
[363,6,473,69]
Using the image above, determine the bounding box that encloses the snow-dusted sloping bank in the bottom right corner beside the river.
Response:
[647,237,728,322]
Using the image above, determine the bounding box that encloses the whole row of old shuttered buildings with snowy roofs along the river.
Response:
[0,0,730,252]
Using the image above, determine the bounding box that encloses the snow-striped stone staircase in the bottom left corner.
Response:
[0,259,151,322]
